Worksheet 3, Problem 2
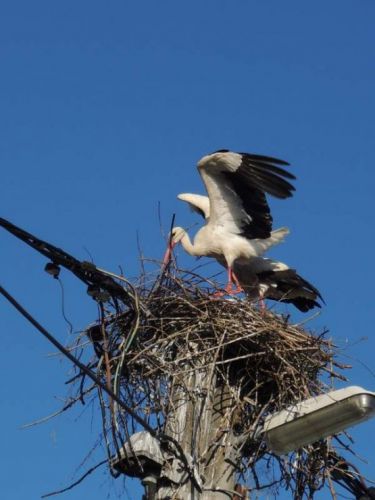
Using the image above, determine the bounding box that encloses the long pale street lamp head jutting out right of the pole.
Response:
[263,386,375,455]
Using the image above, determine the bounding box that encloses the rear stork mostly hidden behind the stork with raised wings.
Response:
[173,193,324,312]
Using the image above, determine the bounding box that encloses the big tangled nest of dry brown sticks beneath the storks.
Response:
[117,274,334,416]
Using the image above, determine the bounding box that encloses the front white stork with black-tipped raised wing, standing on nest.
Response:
[164,150,295,294]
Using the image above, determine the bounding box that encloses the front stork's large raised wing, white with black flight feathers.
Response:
[198,150,295,239]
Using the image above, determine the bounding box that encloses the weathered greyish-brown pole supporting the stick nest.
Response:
[156,345,236,500]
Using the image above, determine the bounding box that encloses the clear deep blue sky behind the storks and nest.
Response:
[0,0,375,500]
